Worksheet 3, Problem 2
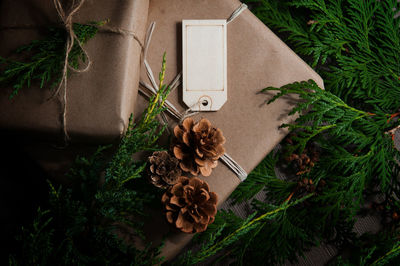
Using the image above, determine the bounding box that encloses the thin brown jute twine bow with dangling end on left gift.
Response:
[50,0,91,142]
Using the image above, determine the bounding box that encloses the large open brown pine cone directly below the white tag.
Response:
[173,118,225,176]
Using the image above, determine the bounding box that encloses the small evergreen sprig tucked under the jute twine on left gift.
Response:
[0,22,100,99]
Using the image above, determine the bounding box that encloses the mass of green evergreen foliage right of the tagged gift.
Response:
[176,0,400,265]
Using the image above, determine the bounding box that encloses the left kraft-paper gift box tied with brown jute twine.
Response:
[0,0,149,142]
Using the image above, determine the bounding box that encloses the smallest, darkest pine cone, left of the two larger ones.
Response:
[149,151,182,188]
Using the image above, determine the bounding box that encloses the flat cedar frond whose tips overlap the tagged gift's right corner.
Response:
[262,80,384,154]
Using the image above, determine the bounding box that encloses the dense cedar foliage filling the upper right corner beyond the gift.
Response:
[246,0,400,113]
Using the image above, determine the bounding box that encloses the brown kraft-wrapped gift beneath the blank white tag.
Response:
[135,0,323,259]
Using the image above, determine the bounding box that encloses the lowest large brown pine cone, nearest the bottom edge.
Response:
[161,176,218,233]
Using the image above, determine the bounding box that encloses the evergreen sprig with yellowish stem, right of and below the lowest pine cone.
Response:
[172,194,313,265]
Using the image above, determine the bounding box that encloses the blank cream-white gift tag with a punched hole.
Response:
[182,20,227,111]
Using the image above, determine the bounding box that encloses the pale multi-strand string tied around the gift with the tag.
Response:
[139,4,248,182]
